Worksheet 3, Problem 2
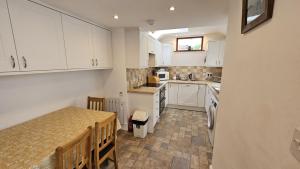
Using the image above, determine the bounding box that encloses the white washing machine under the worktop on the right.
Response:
[207,92,218,146]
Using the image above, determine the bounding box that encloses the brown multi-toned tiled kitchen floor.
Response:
[107,109,212,169]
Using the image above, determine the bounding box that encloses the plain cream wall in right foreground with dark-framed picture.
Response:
[213,0,300,169]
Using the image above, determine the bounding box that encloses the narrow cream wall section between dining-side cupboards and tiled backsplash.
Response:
[103,28,128,130]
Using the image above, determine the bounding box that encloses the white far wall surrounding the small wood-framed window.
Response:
[160,33,225,66]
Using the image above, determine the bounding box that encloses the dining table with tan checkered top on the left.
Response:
[0,107,120,169]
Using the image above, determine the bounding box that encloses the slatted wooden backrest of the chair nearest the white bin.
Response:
[95,114,117,155]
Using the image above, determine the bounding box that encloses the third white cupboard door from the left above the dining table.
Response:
[62,15,92,69]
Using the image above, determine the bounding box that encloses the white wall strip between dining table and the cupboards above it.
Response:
[0,70,104,129]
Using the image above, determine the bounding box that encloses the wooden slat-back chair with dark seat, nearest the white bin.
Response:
[94,114,118,169]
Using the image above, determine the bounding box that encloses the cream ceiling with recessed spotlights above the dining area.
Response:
[41,0,228,31]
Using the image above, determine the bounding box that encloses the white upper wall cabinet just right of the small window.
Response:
[205,41,224,67]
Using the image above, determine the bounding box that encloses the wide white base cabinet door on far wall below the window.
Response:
[178,84,199,107]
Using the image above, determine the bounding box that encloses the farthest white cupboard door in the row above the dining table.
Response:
[91,25,113,68]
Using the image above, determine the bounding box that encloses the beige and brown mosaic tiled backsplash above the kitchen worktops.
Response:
[126,66,222,88]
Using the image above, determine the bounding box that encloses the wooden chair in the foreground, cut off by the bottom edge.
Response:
[56,126,92,169]
